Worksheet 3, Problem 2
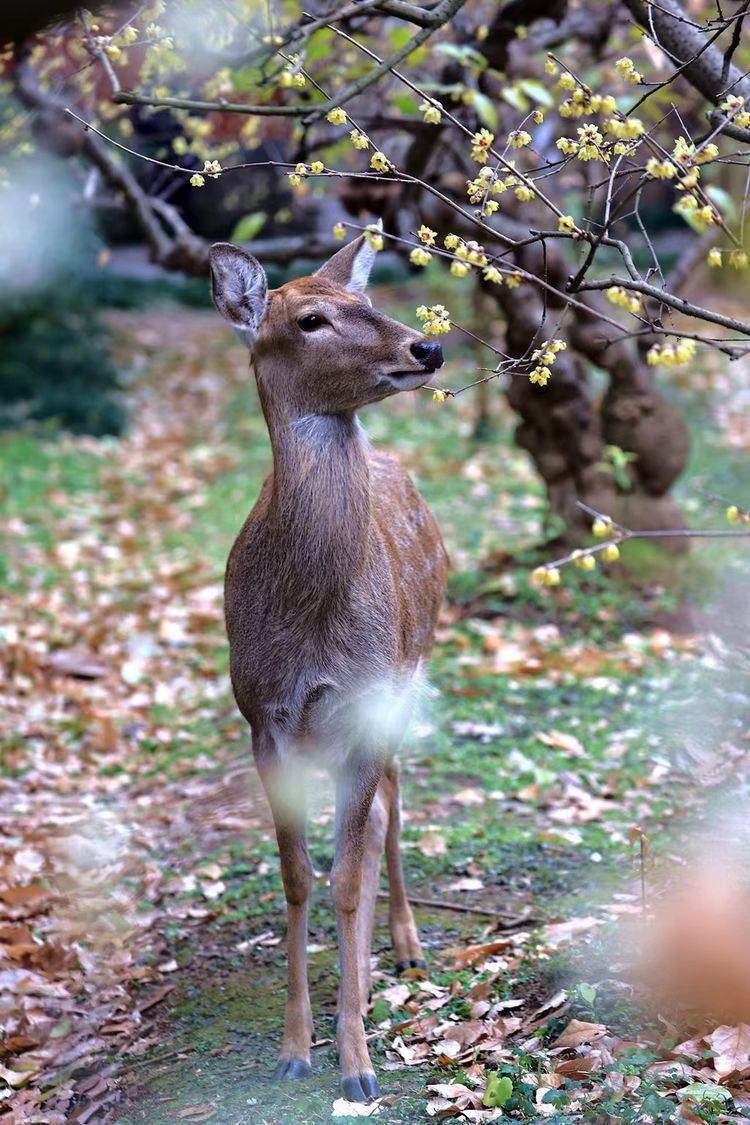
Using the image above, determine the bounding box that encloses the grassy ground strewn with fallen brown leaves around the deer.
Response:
[0,294,750,1125]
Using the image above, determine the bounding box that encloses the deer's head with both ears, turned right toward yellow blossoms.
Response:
[210,228,443,414]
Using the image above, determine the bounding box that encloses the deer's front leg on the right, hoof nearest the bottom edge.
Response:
[331,756,382,1101]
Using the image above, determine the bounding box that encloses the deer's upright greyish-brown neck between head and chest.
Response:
[263,389,371,597]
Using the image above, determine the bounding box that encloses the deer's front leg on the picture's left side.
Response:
[259,759,313,1080]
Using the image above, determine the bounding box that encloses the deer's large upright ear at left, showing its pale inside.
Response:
[208,242,269,348]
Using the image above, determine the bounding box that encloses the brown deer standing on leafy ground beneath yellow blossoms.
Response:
[210,228,446,1101]
